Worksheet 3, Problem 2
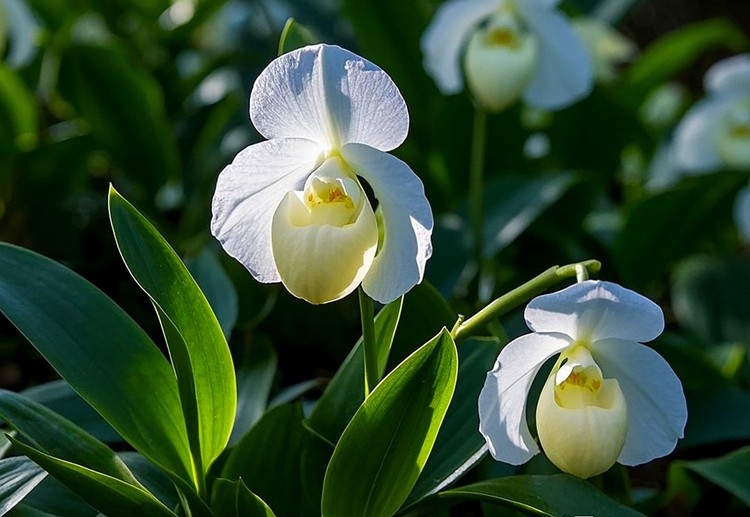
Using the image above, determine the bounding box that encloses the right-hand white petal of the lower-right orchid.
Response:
[593,339,687,465]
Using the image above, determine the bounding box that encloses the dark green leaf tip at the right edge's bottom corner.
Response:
[679,447,750,506]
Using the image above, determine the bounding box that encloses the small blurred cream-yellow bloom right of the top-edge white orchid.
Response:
[573,17,638,82]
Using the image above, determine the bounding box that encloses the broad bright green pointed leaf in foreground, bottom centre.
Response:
[322,329,458,517]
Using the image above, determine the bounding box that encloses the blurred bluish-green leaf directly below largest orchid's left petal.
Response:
[185,248,239,339]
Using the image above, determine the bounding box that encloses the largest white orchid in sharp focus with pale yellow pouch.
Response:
[211,45,433,304]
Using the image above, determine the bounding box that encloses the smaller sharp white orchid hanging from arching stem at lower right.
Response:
[479,280,687,478]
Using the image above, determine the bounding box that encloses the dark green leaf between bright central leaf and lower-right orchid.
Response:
[405,338,500,505]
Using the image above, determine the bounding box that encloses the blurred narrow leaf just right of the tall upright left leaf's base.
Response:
[229,337,279,444]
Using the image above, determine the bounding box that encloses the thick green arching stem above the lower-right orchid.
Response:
[451,260,601,341]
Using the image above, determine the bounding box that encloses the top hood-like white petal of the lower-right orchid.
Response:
[524,280,664,342]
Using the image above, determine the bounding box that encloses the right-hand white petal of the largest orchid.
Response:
[341,144,433,303]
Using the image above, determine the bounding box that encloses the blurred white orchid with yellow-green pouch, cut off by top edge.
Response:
[421,0,593,111]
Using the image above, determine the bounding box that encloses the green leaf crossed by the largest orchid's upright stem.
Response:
[307,296,408,443]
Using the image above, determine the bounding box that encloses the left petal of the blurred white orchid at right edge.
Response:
[673,96,731,173]
